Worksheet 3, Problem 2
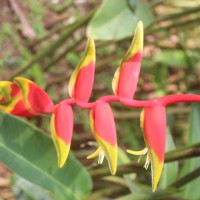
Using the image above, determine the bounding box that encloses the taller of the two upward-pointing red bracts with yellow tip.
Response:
[112,21,143,98]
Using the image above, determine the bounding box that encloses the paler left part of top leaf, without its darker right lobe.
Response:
[87,0,137,40]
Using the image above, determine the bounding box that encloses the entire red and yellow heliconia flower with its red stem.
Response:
[0,22,200,191]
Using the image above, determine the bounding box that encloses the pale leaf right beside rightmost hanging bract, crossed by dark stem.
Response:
[159,127,178,188]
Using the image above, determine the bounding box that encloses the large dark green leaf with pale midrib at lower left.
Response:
[0,113,92,200]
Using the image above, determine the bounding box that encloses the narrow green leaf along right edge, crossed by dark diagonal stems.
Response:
[180,103,200,200]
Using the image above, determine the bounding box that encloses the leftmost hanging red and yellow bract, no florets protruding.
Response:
[51,103,73,167]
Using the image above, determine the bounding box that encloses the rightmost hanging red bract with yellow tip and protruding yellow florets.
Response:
[128,105,166,192]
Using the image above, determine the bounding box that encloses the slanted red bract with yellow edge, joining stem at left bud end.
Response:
[14,77,54,115]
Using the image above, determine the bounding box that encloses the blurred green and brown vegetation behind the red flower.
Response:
[0,0,200,200]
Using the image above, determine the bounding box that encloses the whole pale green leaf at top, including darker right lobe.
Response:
[87,0,153,40]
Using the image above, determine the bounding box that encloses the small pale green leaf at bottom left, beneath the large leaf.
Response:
[11,175,54,200]
